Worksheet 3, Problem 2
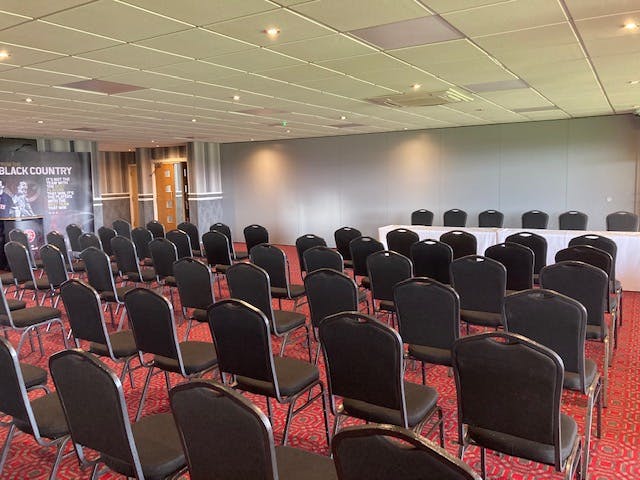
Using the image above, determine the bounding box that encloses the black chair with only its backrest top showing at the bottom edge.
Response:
[331,425,481,480]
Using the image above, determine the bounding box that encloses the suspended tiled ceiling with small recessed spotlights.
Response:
[0,0,640,150]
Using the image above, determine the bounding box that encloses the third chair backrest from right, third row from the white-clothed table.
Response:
[367,250,413,302]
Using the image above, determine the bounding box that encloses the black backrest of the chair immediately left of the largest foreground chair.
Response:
[318,312,407,427]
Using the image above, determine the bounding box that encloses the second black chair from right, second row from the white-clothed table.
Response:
[484,242,535,293]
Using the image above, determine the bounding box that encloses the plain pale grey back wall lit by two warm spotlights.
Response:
[221,115,640,244]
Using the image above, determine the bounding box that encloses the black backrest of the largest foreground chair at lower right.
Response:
[453,332,564,466]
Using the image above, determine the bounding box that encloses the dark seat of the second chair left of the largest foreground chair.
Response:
[236,357,320,397]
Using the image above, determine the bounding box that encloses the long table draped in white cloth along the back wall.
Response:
[378,225,640,292]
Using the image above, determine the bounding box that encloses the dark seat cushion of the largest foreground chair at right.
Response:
[468,413,578,465]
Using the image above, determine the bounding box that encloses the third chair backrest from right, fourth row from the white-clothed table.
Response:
[304,270,358,328]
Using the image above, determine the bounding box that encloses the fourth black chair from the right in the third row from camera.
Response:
[227,262,311,361]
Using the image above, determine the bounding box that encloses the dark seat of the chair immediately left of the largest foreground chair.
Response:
[342,382,438,428]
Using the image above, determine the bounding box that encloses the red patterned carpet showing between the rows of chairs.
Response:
[0,247,640,480]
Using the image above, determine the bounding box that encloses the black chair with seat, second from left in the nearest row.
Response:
[49,350,186,480]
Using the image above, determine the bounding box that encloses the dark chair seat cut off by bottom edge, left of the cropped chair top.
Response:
[276,446,338,480]
